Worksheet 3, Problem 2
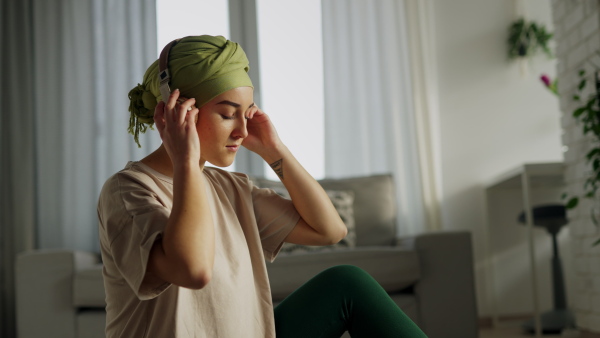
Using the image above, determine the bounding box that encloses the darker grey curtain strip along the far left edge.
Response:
[0,0,35,337]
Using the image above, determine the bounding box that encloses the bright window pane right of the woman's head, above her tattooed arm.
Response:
[257,0,325,179]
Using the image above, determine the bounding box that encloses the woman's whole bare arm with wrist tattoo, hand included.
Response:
[243,108,348,245]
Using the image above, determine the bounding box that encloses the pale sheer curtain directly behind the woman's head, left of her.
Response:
[33,0,160,251]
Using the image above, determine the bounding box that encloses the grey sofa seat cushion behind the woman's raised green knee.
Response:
[267,247,421,300]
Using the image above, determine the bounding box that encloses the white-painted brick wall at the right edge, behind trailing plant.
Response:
[552,0,600,333]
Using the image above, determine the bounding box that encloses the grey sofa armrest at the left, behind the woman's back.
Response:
[15,250,99,338]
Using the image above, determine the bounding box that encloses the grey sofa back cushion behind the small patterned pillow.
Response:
[251,174,396,246]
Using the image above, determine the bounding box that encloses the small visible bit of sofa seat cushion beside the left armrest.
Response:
[73,264,106,308]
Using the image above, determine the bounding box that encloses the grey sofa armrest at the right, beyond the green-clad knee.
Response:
[396,232,478,338]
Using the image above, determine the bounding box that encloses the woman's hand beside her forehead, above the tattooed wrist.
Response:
[242,106,282,158]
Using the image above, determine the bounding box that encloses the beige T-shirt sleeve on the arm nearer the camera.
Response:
[99,175,170,300]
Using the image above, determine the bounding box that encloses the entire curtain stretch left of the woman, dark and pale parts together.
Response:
[0,0,159,337]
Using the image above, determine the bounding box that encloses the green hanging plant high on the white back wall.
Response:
[508,18,554,60]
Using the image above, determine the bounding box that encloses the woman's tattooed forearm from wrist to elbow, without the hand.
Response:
[261,145,347,244]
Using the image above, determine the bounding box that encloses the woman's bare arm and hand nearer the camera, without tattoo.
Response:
[146,91,215,289]
